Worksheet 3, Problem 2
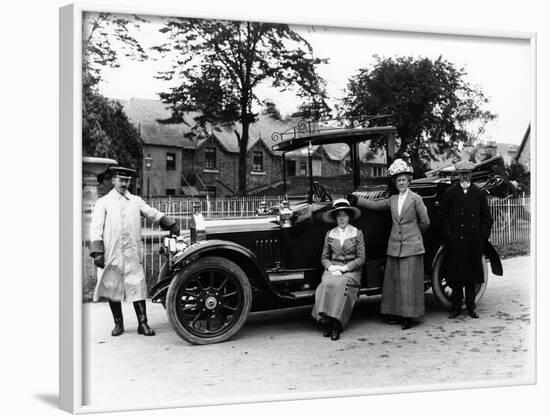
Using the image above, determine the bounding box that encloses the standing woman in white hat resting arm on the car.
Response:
[350,159,430,330]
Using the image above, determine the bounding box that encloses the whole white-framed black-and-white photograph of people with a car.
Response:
[60,4,536,413]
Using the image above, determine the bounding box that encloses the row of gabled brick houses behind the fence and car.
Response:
[119,98,392,196]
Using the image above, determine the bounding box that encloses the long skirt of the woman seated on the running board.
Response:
[311,271,361,329]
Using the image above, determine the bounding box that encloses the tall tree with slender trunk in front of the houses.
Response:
[155,18,326,195]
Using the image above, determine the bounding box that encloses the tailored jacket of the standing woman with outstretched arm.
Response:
[357,190,430,258]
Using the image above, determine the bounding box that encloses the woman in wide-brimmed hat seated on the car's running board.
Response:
[311,198,365,340]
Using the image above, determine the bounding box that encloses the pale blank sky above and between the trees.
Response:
[99,13,533,144]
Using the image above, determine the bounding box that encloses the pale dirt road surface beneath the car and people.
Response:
[83,257,534,407]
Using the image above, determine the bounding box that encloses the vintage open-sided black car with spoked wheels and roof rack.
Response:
[152,118,508,344]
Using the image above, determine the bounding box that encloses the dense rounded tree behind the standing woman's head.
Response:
[341,56,495,175]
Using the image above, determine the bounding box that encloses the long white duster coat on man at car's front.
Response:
[90,188,164,301]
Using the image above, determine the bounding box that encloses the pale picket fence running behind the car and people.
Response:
[85,196,531,288]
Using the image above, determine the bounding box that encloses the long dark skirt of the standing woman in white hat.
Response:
[380,255,424,317]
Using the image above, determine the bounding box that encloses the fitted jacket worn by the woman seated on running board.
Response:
[321,225,365,283]
